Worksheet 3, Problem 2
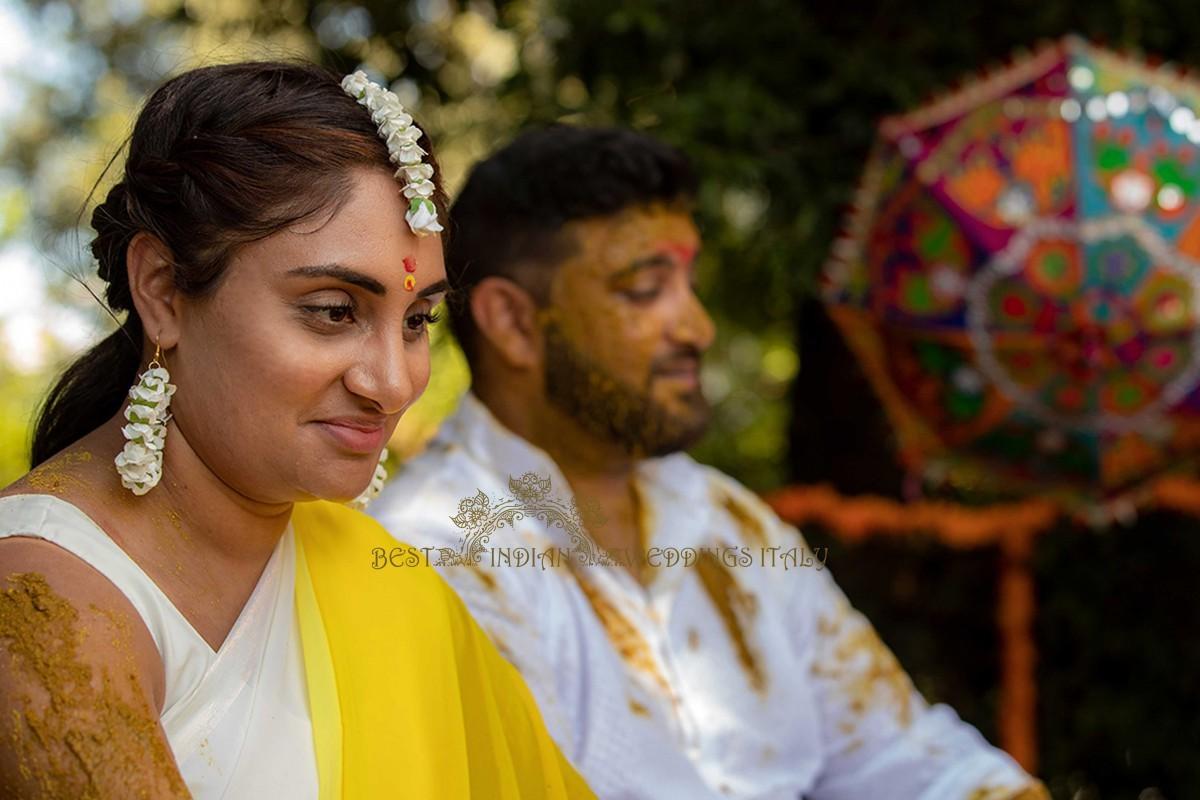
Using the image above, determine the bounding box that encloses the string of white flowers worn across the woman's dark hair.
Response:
[342,70,442,236]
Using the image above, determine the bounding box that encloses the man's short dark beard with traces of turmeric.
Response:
[544,323,709,458]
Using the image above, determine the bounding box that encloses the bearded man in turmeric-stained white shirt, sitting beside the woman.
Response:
[372,127,1048,800]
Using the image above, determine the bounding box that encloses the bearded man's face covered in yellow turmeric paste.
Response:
[544,205,713,457]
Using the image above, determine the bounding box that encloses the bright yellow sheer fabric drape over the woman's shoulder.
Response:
[292,503,595,800]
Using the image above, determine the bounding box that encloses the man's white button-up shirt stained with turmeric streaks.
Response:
[370,395,1046,800]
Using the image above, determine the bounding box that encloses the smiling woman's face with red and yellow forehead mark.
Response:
[167,169,445,503]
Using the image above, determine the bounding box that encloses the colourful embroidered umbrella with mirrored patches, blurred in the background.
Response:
[824,37,1200,524]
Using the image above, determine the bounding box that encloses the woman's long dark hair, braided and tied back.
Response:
[30,61,446,467]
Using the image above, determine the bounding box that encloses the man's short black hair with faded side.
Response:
[445,125,696,362]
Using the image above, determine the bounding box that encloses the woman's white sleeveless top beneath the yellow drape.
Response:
[0,494,317,800]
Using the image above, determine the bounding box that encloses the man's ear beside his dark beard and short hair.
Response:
[470,276,541,369]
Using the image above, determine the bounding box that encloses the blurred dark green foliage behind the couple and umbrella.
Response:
[0,0,1200,800]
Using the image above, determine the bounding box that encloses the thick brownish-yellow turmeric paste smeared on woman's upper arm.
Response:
[0,572,190,800]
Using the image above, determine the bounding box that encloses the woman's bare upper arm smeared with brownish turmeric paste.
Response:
[0,537,191,800]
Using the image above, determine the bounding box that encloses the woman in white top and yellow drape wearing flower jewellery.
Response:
[0,62,590,800]
